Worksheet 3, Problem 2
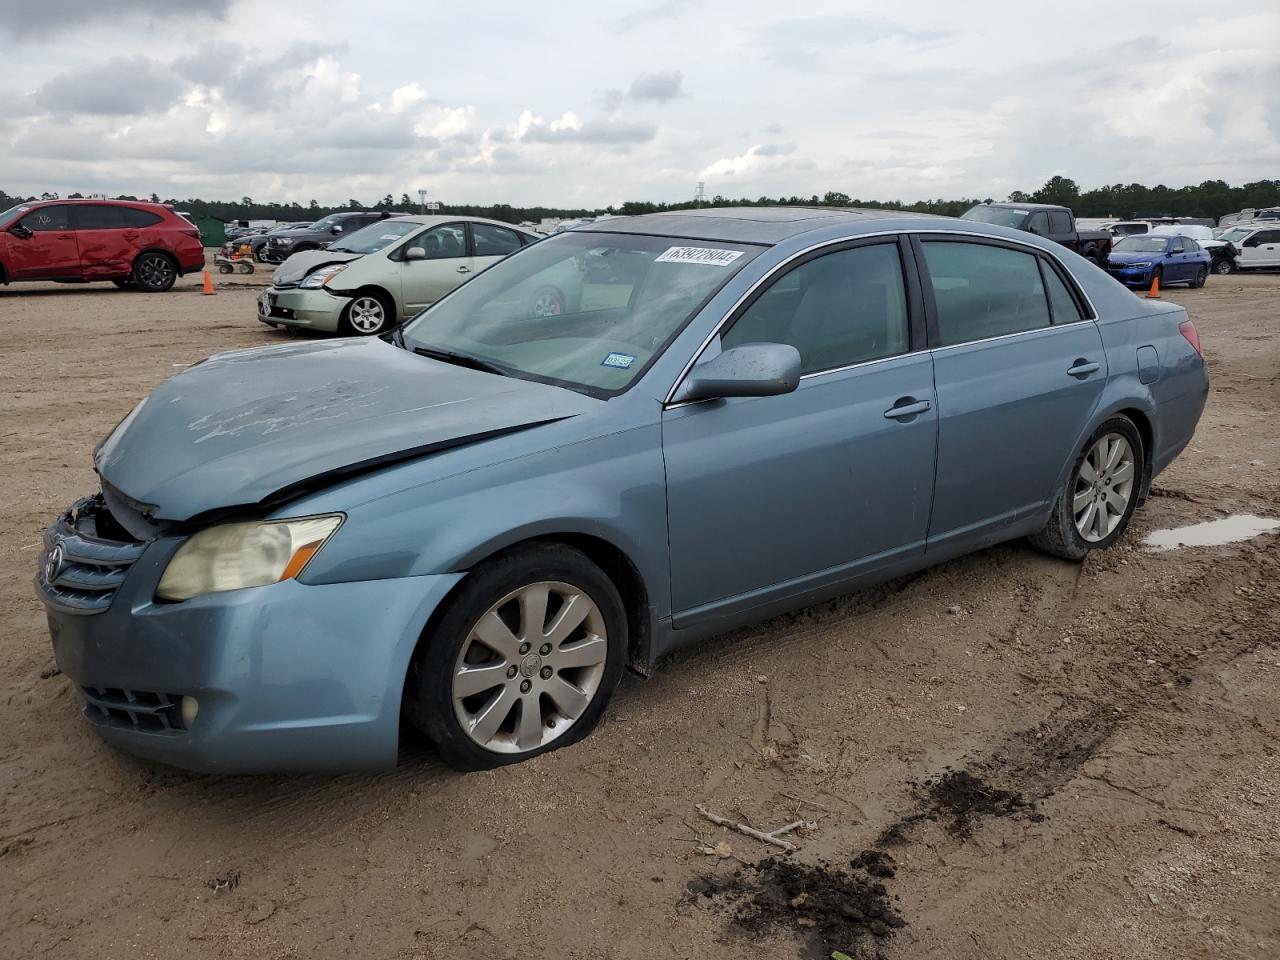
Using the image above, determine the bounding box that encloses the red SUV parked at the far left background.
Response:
[0,200,205,292]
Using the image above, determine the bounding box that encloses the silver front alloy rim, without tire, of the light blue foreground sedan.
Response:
[452,581,609,754]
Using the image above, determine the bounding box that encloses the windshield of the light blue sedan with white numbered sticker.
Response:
[404,232,759,396]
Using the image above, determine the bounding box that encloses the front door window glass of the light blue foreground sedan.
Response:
[721,243,909,374]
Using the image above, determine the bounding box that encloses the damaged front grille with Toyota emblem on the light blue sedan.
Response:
[36,494,146,613]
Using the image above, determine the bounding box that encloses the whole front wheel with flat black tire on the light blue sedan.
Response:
[406,544,627,771]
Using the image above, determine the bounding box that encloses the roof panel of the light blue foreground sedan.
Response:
[575,206,924,244]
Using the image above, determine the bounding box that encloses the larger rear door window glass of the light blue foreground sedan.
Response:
[923,241,1050,347]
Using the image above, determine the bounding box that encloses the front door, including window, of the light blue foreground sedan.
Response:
[663,239,937,628]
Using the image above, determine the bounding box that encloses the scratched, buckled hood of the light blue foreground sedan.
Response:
[93,339,603,521]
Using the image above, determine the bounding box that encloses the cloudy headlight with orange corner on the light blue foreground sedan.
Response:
[156,513,343,600]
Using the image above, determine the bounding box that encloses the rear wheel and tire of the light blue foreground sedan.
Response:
[1028,416,1146,561]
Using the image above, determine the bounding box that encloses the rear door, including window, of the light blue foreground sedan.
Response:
[915,234,1107,558]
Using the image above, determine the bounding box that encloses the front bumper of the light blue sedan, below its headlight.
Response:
[37,527,461,773]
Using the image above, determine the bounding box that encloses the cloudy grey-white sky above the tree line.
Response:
[0,0,1280,206]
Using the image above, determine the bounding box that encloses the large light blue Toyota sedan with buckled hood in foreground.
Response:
[36,207,1208,772]
